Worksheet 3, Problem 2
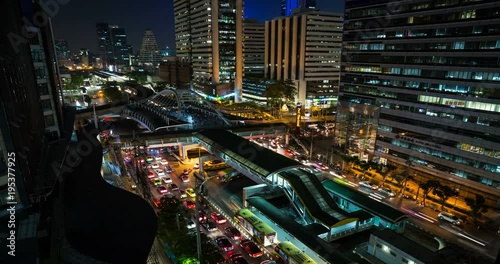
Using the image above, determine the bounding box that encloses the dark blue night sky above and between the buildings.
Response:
[52,0,344,53]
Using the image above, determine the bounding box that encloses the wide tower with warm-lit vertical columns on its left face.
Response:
[264,9,342,109]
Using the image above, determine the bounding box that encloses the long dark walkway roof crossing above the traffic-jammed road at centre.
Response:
[194,129,303,179]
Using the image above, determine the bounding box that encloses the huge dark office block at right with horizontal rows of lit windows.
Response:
[336,0,500,205]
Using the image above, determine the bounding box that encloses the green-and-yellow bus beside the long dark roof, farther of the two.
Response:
[234,208,278,247]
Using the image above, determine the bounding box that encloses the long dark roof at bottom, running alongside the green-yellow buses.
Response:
[247,196,355,264]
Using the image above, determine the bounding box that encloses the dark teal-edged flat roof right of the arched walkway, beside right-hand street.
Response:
[323,180,408,223]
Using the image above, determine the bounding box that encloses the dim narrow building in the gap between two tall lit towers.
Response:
[243,19,266,78]
